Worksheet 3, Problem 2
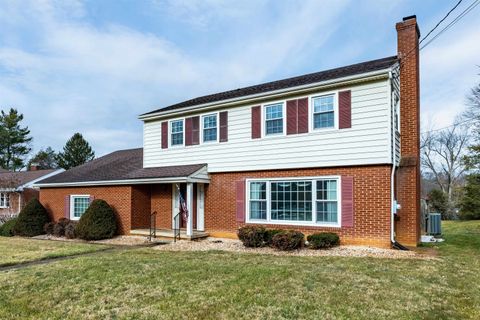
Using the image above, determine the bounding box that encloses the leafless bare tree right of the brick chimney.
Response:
[420,122,470,206]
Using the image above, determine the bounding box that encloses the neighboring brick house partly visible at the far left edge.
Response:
[0,167,64,216]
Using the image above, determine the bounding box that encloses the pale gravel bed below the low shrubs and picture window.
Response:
[153,238,433,259]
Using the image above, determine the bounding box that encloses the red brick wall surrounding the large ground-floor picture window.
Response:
[205,165,391,247]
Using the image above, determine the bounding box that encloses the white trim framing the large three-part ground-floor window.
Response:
[245,176,342,228]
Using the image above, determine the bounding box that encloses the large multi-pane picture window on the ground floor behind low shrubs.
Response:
[247,177,340,226]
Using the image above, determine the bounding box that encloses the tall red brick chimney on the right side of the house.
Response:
[395,16,420,246]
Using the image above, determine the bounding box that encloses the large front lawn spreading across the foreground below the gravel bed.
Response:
[0,222,480,319]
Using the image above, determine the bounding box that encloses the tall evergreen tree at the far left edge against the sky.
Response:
[0,108,32,171]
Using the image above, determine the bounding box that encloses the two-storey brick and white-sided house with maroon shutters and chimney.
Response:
[39,16,420,247]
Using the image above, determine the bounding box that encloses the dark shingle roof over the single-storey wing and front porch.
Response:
[38,148,205,184]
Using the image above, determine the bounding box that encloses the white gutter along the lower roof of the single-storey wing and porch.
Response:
[34,177,210,188]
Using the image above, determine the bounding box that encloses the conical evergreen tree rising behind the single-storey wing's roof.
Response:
[57,132,95,170]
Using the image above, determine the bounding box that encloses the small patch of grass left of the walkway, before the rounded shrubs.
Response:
[0,237,107,267]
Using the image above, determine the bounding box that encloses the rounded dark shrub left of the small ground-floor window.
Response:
[13,198,50,237]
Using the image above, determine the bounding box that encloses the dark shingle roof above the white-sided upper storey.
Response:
[142,56,397,116]
